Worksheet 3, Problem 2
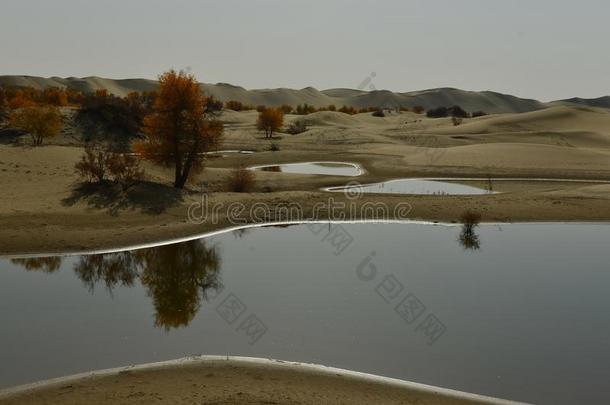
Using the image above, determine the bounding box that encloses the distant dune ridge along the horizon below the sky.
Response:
[0,76,610,113]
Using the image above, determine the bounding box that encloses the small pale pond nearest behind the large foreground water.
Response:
[326,179,494,195]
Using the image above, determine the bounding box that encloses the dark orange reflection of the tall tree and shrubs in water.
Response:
[74,240,221,330]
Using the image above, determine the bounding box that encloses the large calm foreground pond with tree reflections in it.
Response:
[0,223,610,404]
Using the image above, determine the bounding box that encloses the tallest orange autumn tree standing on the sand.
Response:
[136,70,223,188]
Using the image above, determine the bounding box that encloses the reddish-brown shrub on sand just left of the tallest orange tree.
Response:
[74,144,144,189]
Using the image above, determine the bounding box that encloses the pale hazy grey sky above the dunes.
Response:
[0,0,610,101]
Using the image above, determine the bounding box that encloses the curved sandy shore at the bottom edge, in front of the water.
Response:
[0,356,514,405]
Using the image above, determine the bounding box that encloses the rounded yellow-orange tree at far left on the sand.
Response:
[10,106,63,145]
